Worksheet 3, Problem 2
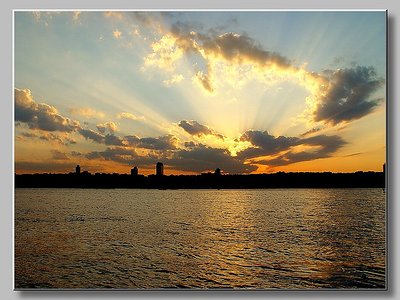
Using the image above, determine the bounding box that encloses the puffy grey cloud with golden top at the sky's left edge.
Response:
[14,89,79,132]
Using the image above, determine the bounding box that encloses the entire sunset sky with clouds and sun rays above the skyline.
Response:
[14,11,386,174]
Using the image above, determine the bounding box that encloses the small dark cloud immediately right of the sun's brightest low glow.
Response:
[237,130,299,159]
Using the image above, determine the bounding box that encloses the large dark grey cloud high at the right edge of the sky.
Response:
[314,66,384,125]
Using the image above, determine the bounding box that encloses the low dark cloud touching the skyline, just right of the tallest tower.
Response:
[165,144,257,173]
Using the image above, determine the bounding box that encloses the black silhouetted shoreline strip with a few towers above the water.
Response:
[15,162,386,189]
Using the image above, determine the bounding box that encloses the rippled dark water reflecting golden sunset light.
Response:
[15,189,386,289]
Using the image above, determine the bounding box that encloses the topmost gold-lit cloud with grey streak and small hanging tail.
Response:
[145,22,298,84]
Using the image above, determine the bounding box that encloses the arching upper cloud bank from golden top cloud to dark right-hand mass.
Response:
[145,22,384,126]
